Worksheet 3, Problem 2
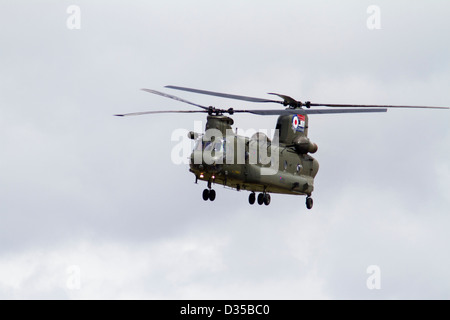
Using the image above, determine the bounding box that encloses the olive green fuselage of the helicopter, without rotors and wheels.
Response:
[190,116,319,196]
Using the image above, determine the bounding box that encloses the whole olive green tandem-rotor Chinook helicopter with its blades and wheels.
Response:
[116,86,449,209]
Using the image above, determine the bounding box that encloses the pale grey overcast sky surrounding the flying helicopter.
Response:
[0,0,450,299]
